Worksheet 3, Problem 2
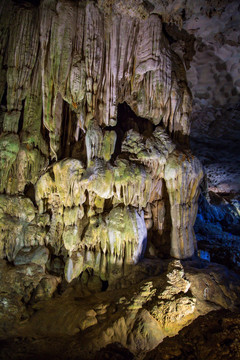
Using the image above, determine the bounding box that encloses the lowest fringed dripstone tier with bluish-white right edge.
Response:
[63,206,147,281]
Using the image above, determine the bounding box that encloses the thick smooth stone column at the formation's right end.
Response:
[164,151,203,259]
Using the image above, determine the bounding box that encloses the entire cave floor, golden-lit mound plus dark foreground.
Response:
[0,259,240,360]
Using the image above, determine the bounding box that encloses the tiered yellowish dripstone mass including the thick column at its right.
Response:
[33,125,203,281]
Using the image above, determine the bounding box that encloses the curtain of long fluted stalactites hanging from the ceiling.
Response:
[0,0,191,157]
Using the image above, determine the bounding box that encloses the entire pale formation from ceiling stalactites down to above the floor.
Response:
[0,0,203,282]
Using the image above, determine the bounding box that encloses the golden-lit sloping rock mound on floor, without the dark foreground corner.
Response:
[1,260,240,359]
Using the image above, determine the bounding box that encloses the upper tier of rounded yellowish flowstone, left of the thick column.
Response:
[36,125,178,212]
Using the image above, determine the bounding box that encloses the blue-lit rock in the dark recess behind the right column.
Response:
[194,192,240,272]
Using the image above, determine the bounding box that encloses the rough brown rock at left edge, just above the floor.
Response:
[0,260,61,338]
